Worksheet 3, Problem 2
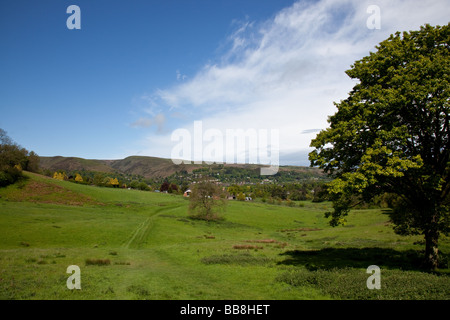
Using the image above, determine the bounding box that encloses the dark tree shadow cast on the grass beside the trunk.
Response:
[278,248,423,271]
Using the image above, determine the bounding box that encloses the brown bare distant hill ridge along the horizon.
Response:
[40,156,323,179]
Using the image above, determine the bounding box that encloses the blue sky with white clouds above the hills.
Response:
[0,0,450,165]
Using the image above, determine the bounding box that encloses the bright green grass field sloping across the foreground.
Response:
[0,173,450,300]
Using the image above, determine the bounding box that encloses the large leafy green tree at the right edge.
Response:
[309,23,450,269]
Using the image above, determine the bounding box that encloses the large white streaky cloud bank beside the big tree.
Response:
[136,0,450,163]
